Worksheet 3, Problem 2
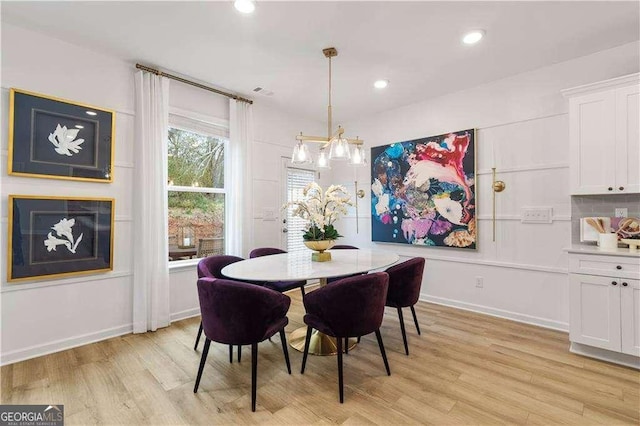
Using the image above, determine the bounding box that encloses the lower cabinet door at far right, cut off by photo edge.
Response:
[620,279,640,356]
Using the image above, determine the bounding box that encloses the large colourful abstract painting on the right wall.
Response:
[371,129,477,249]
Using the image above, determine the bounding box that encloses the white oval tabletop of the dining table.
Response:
[222,249,399,281]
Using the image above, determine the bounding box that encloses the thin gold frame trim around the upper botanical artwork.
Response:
[7,87,116,183]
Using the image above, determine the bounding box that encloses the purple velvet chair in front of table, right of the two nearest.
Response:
[300,272,391,403]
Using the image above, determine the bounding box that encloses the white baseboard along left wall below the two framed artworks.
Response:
[0,324,133,365]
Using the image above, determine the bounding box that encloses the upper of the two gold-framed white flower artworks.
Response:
[9,89,115,182]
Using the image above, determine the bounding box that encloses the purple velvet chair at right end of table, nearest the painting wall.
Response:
[385,257,425,355]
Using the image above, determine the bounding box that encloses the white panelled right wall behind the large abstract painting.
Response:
[332,42,640,330]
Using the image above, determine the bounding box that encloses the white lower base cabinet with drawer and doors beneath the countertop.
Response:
[569,254,640,357]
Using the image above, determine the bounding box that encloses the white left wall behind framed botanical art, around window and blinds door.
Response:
[0,23,322,364]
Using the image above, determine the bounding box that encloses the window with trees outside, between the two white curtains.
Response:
[167,115,228,261]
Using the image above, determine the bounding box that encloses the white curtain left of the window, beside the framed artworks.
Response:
[133,71,170,333]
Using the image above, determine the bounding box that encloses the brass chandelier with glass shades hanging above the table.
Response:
[291,47,366,169]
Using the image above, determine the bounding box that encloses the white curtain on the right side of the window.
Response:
[225,99,253,257]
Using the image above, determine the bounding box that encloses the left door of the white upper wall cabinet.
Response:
[569,90,616,194]
